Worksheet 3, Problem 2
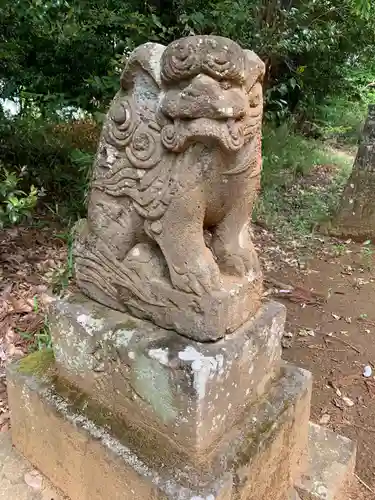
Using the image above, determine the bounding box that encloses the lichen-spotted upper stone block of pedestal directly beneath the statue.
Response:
[49,294,285,459]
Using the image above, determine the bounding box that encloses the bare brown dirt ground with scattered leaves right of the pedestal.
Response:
[257,230,375,500]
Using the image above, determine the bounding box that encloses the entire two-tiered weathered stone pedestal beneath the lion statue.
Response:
[8,295,353,500]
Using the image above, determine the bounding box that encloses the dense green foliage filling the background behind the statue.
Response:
[0,0,375,229]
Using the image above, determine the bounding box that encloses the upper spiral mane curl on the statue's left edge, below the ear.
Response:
[106,100,138,148]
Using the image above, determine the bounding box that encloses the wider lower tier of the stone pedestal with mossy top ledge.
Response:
[8,354,311,500]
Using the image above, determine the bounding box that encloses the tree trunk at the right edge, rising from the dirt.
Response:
[330,105,375,241]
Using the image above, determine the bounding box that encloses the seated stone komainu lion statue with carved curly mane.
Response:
[74,36,264,340]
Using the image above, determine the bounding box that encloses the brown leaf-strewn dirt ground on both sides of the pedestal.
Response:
[0,226,375,500]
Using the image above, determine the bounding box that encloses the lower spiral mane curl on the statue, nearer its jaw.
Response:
[125,123,162,169]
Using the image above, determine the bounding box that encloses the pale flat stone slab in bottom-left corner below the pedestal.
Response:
[0,432,68,500]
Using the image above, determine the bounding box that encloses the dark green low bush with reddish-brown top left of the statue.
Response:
[0,116,99,220]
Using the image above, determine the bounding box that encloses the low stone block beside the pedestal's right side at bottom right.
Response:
[296,423,356,500]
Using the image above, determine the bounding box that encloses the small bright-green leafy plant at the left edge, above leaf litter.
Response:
[0,163,41,228]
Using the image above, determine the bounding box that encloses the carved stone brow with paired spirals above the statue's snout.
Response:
[162,36,245,83]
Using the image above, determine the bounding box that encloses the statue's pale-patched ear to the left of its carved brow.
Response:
[120,42,165,90]
